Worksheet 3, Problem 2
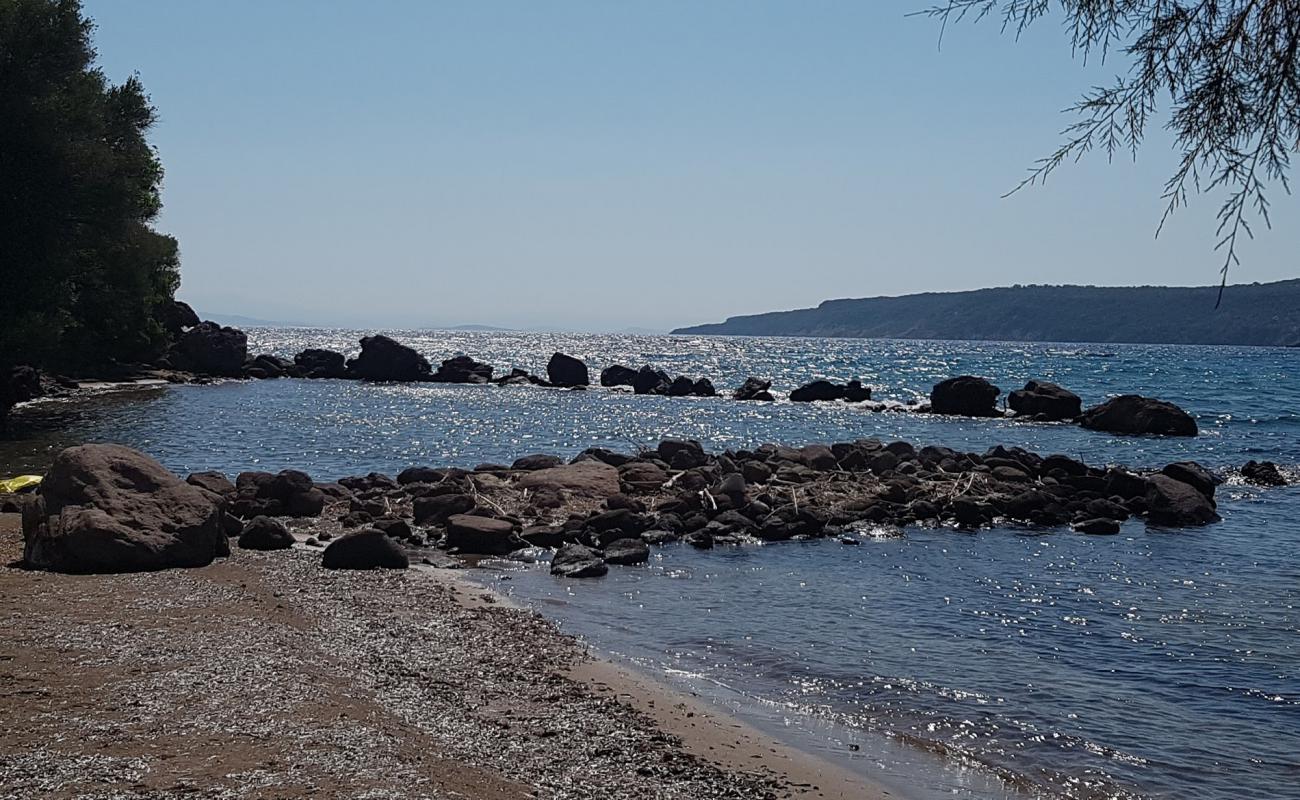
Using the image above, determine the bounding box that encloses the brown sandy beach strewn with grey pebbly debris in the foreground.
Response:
[0,514,889,799]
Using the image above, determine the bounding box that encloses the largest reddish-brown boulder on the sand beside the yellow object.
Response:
[22,445,230,572]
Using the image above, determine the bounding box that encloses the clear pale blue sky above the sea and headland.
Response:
[86,0,1300,329]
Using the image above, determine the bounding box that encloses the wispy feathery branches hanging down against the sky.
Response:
[923,0,1300,299]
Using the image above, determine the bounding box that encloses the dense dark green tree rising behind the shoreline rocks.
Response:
[0,0,179,366]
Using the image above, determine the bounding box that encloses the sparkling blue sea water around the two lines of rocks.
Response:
[0,329,1300,800]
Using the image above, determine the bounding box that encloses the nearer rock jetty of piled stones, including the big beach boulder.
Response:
[15,440,1287,578]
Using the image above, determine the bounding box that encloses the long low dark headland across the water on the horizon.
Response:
[673,278,1300,346]
